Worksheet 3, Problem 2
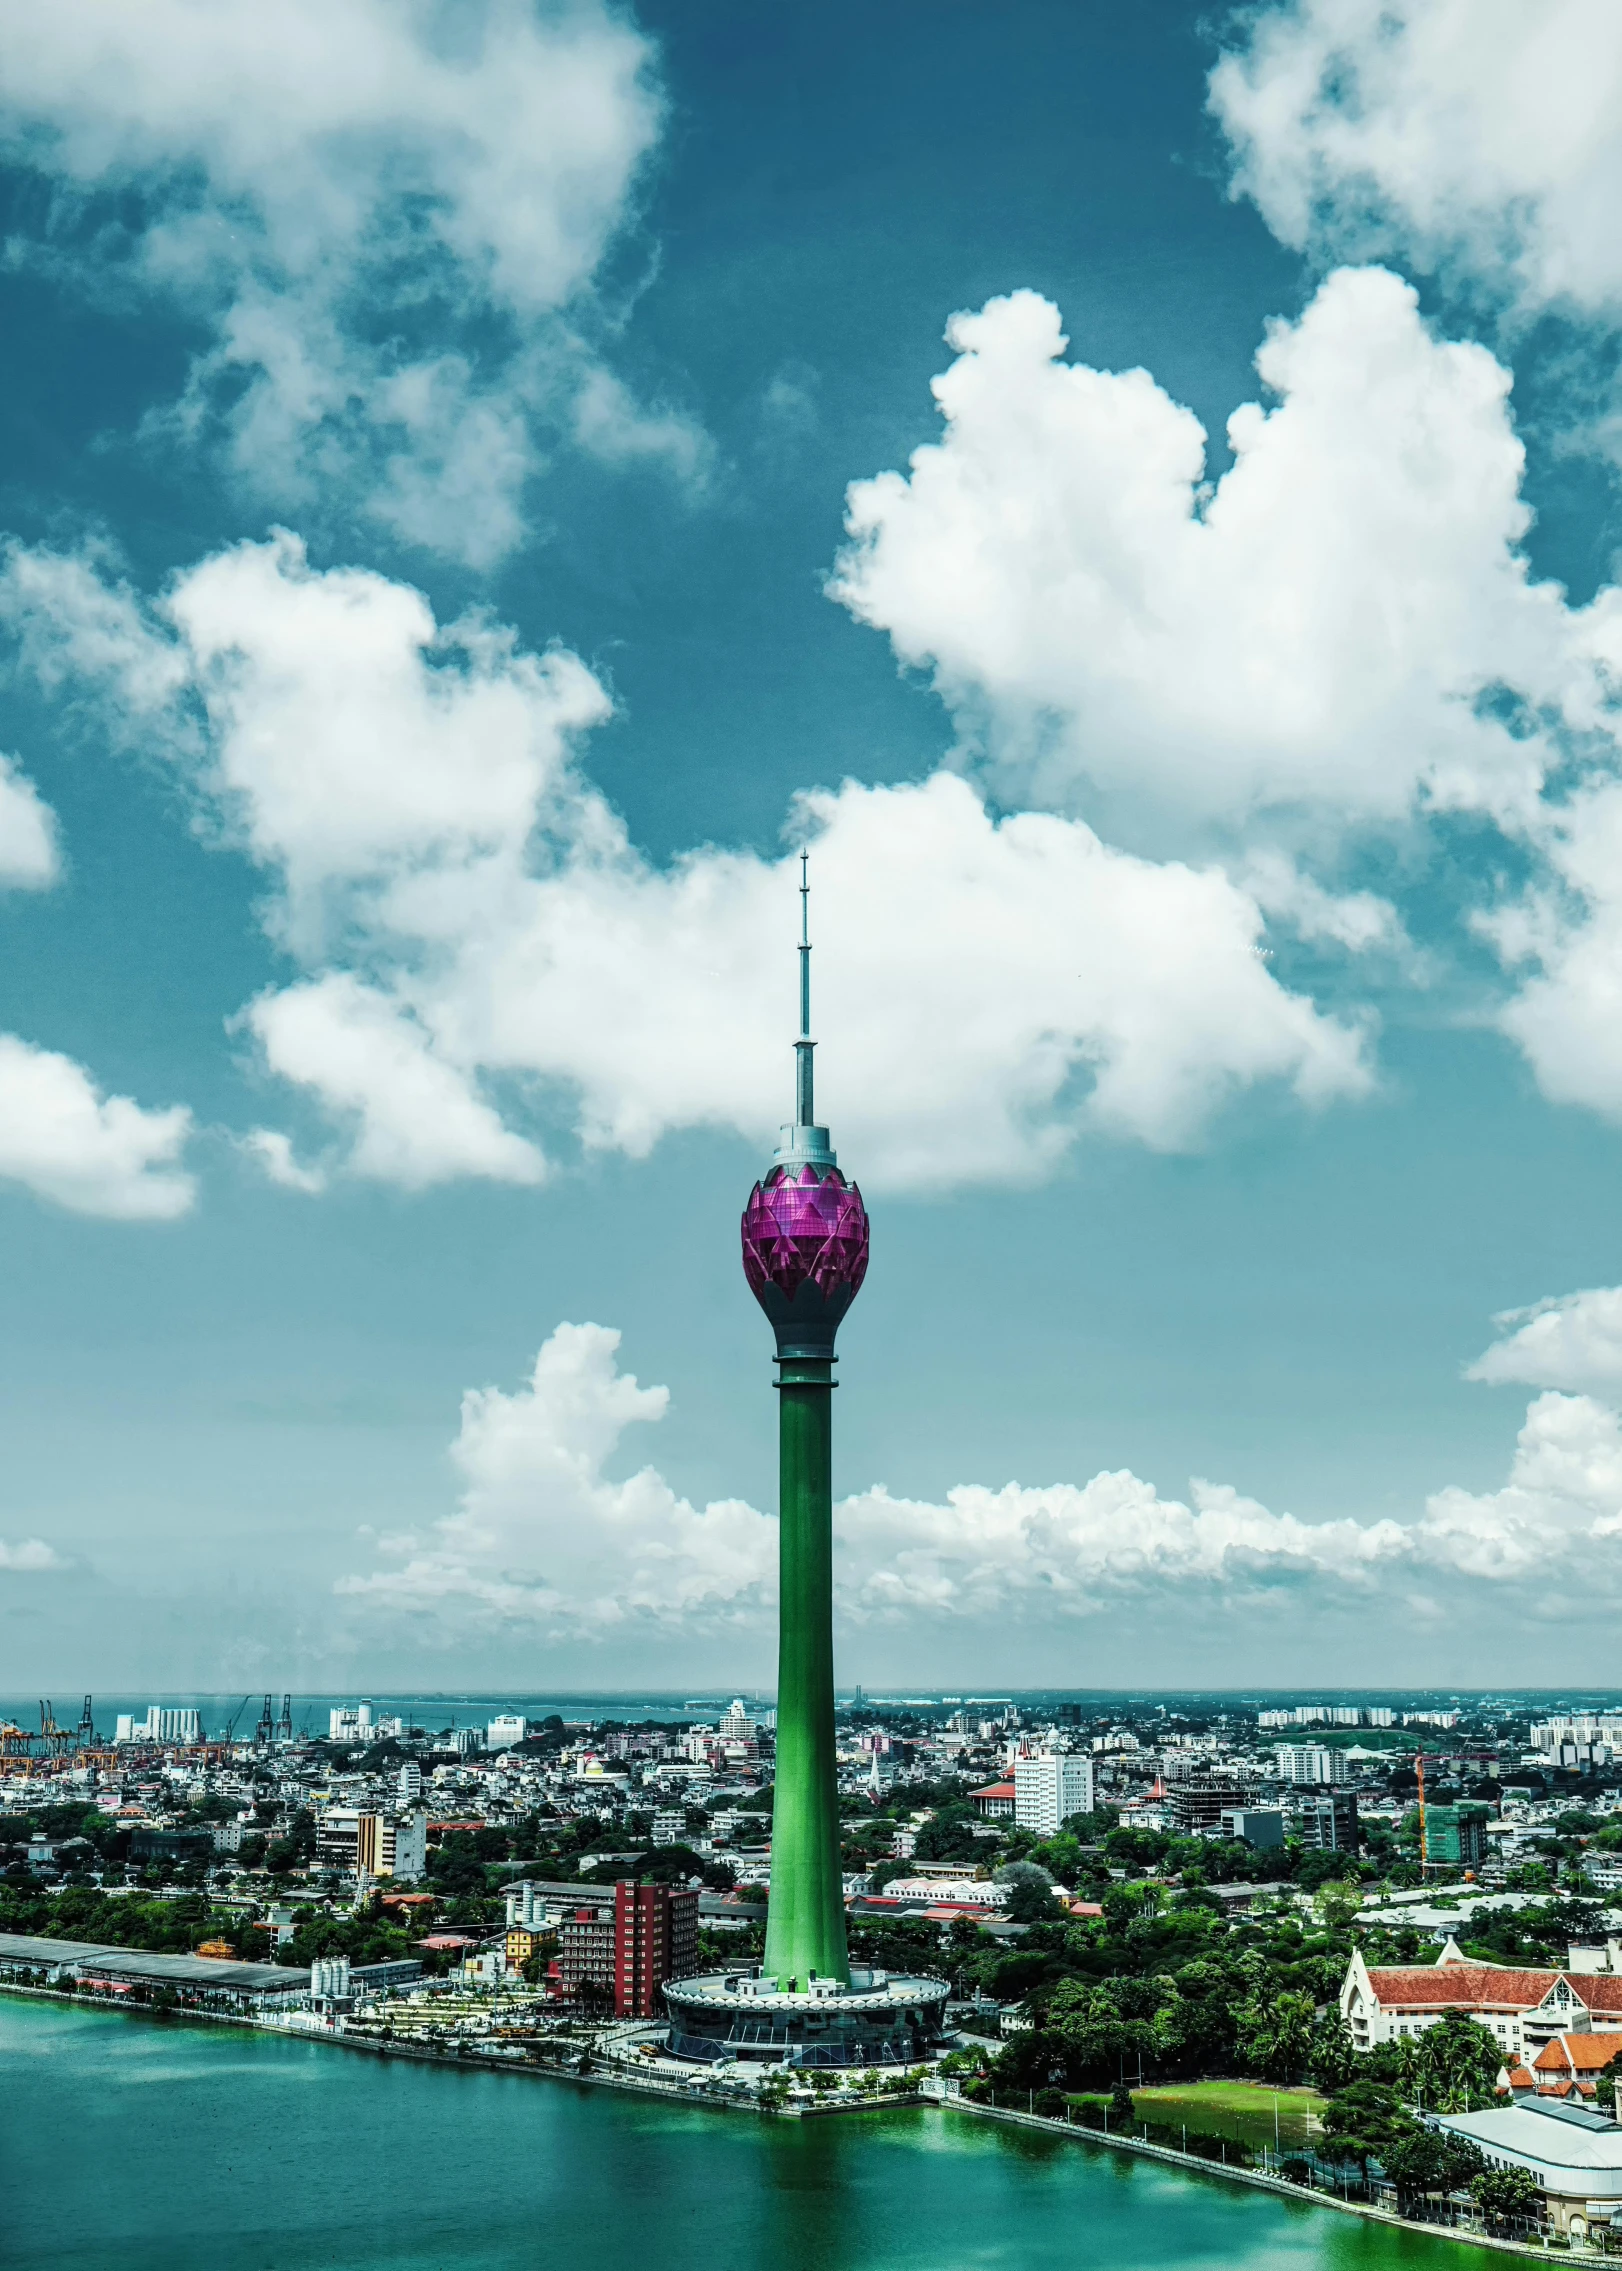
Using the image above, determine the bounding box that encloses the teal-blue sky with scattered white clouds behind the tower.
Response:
[0,0,1622,1692]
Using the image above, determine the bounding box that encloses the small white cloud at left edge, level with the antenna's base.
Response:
[0,1033,195,1222]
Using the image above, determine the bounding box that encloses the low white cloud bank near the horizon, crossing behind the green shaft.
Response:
[338,1324,1622,1637]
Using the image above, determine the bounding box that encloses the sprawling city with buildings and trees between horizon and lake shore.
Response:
[0,1690,1622,2230]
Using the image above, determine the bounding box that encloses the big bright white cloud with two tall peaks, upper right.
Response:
[831,268,1620,829]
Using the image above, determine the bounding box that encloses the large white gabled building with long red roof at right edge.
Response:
[1340,1939,1622,2067]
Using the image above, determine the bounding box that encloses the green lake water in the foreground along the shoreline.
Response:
[0,1996,1504,2271]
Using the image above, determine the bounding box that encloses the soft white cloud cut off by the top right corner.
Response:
[1211,0,1622,320]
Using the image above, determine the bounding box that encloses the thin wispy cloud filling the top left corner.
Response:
[0,0,702,565]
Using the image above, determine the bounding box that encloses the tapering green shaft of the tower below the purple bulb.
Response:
[766,1356,850,1987]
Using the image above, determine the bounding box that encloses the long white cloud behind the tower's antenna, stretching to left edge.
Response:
[0,536,1370,1188]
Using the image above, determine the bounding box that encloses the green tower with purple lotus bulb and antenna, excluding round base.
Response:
[743,854,868,1989]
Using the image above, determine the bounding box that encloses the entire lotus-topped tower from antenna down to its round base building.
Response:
[666,854,947,2064]
